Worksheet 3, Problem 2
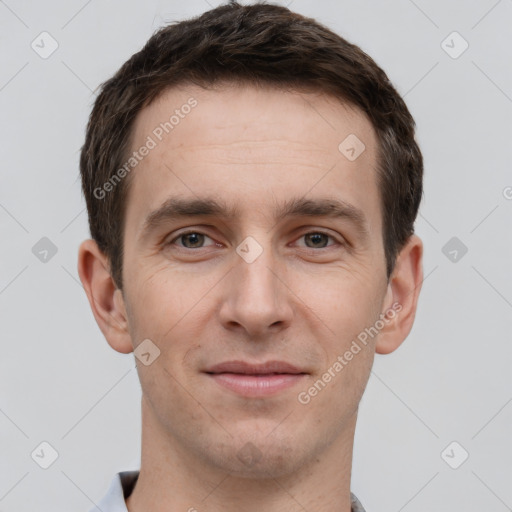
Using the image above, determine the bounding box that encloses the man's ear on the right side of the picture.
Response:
[375,235,423,354]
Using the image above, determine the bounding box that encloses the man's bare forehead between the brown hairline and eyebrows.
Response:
[125,85,380,239]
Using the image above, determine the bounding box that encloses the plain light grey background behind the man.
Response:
[0,0,512,512]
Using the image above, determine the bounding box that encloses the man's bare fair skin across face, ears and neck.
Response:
[78,84,423,512]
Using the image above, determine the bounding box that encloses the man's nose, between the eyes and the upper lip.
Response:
[219,241,293,338]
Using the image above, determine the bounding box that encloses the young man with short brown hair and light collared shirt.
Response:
[78,2,423,512]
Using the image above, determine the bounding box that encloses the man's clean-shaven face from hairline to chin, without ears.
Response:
[119,82,387,476]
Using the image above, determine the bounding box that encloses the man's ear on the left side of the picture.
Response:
[78,240,133,354]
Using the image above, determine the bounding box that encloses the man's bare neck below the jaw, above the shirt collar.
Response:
[126,397,357,512]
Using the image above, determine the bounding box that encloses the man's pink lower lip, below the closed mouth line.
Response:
[209,373,305,397]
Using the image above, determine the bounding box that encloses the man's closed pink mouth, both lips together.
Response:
[204,361,308,398]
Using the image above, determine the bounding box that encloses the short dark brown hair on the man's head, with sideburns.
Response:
[80,1,423,288]
